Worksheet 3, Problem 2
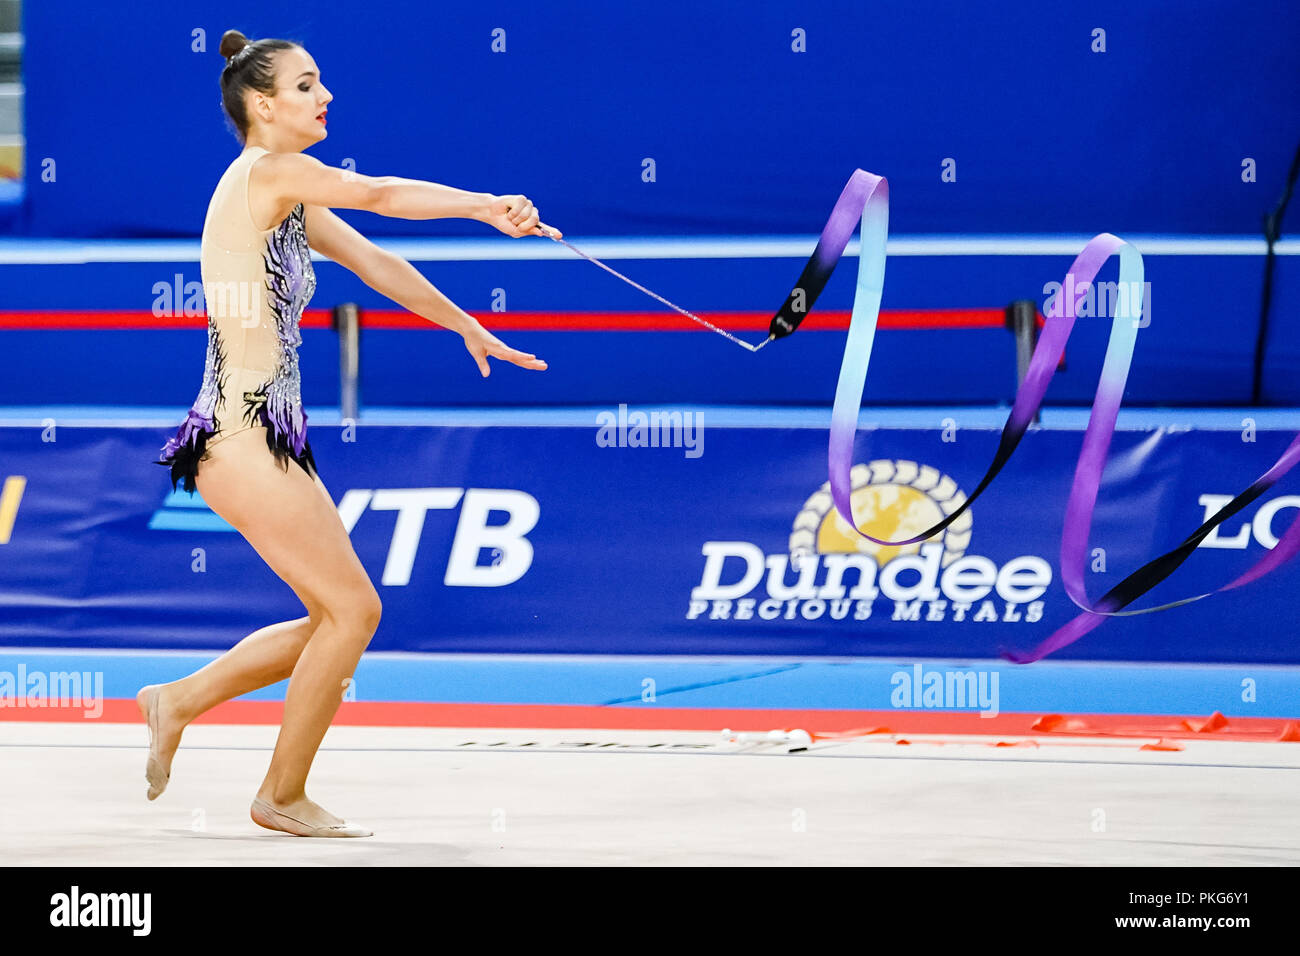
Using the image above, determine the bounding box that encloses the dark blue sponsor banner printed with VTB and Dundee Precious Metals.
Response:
[0,421,1300,663]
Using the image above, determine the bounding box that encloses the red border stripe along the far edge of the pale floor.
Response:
[0,700,1300,743]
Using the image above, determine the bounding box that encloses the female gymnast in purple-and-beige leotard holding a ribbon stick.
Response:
[137,30,560,836]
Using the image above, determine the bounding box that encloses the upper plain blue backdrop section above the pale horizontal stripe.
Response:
[9,0,1300,237]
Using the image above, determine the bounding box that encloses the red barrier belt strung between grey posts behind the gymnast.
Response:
[0,308,1024,332]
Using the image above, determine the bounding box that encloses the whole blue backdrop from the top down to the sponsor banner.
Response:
[0,0,1300,407]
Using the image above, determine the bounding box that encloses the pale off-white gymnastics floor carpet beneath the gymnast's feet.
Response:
[0,722,1300,866]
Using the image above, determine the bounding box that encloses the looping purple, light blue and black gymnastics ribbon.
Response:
[770,169,1300,663]
